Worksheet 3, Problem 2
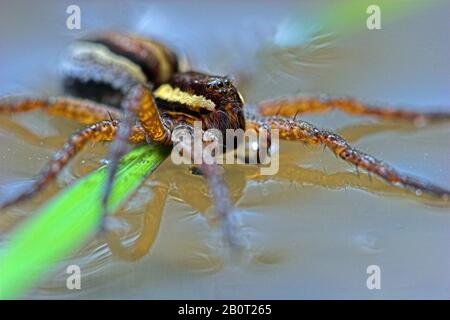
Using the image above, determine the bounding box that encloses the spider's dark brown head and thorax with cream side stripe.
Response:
[155,71,245,134]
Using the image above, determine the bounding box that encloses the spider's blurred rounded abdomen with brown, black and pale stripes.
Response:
[62,33,178,107]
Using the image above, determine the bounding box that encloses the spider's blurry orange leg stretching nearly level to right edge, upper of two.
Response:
[258,96,450,125]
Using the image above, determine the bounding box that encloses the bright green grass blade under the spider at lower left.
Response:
[0,145,170,299]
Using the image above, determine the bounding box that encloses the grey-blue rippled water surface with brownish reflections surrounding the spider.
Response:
[0,0,450,299]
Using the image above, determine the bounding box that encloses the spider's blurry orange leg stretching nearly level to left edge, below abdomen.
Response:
[0,97,121,124]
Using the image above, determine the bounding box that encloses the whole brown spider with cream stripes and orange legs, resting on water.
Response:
[0,33,450,246]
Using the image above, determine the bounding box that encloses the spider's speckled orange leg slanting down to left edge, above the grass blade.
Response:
[0,120,145,208]
